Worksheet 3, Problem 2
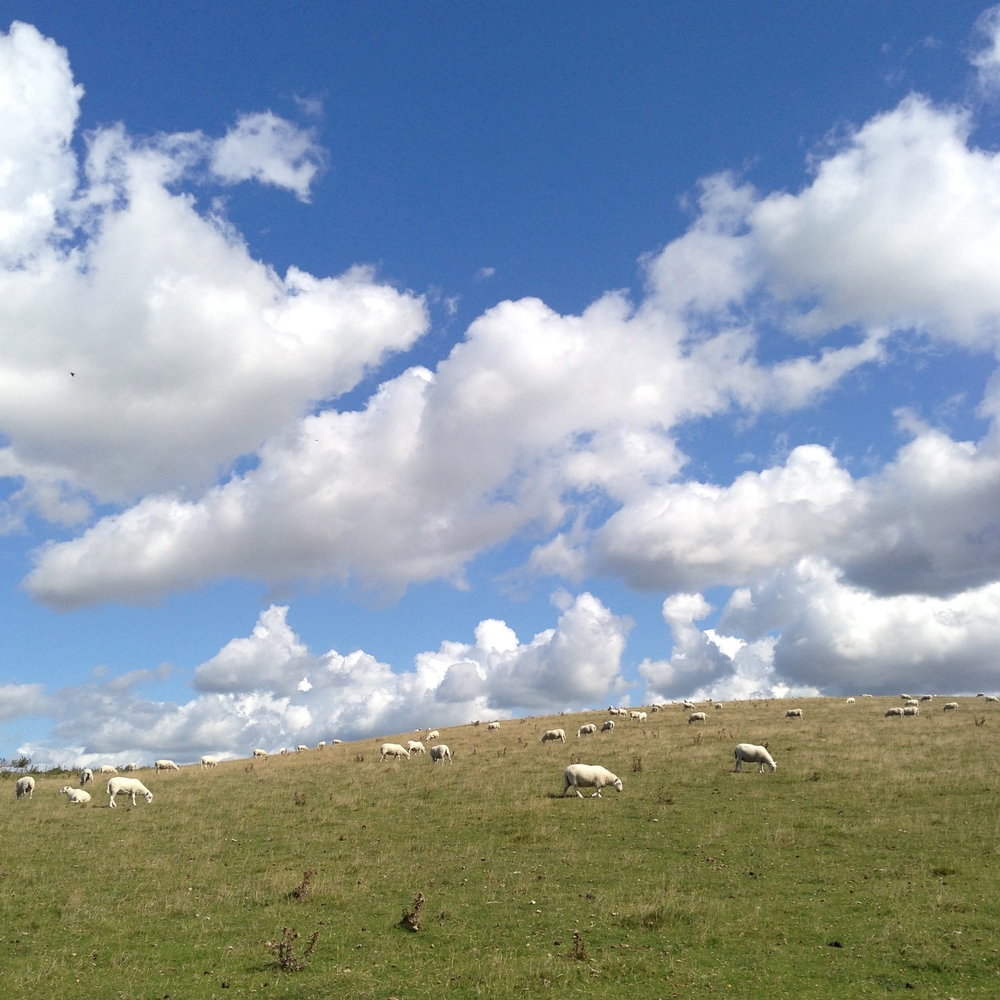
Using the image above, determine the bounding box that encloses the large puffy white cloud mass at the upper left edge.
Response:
[0,24,427,523]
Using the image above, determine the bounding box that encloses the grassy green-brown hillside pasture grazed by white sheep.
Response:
[0,698,1000,1000]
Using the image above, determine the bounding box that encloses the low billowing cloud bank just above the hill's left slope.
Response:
[19,593,631,764]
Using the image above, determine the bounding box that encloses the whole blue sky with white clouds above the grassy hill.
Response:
[0,2,1000,762]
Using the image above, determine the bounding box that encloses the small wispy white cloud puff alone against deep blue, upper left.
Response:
[211,111,325,201]
